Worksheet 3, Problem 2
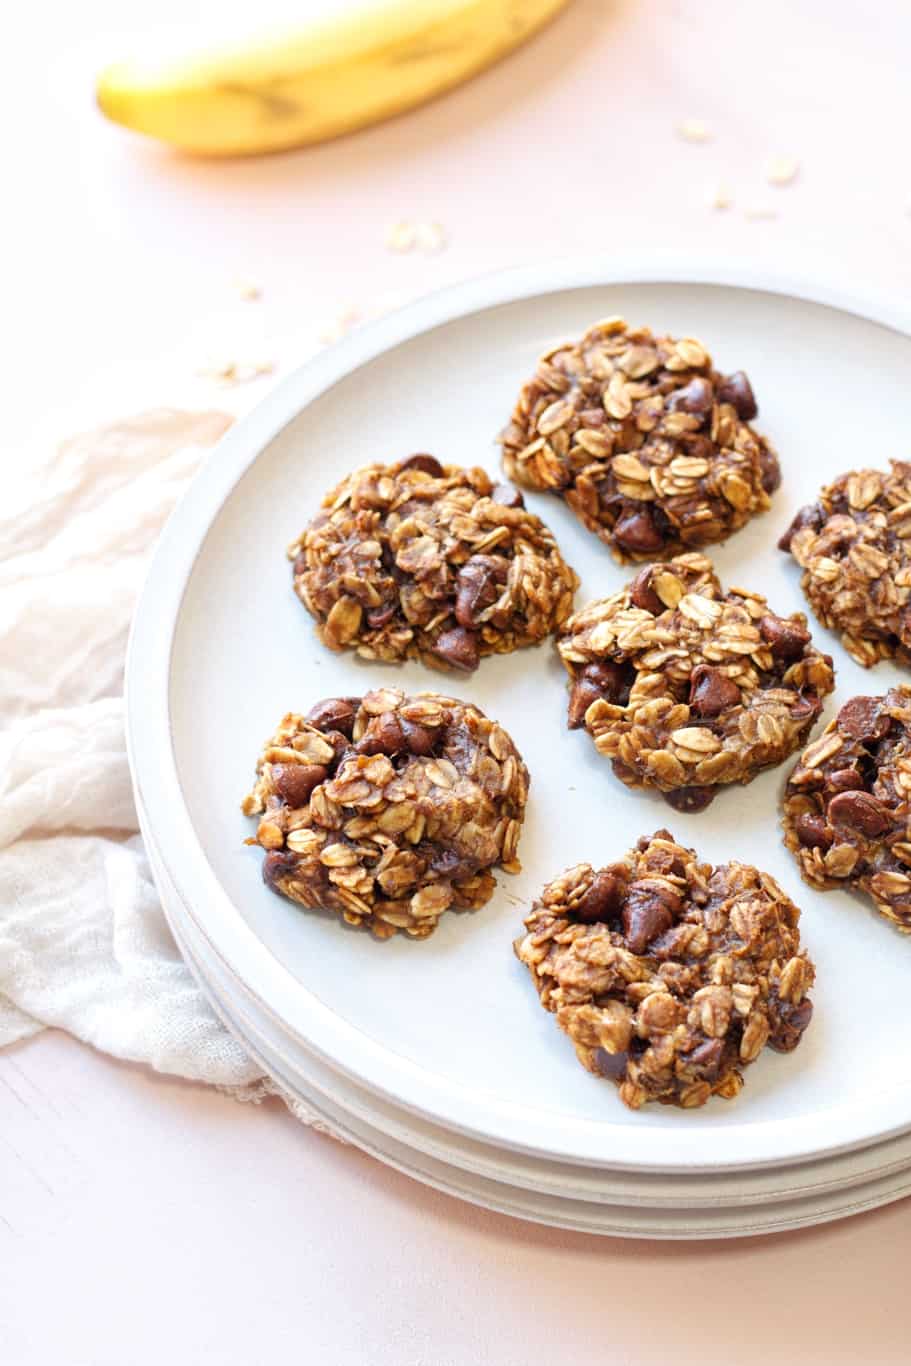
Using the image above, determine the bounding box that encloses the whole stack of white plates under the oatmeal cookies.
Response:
[127,257,911,1238]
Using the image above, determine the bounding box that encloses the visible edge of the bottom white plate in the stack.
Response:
[152,830,911,1240]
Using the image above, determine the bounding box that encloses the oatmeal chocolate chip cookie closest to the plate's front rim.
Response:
[515,831,814,1109]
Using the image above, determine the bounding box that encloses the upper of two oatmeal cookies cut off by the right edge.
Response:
[779,460,911,668]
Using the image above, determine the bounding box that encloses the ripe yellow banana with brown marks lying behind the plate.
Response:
[96,0,568,156]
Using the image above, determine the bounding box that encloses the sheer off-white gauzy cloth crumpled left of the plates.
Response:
[0,411,327,1123]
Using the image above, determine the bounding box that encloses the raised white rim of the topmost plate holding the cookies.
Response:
[124,250,911,1172]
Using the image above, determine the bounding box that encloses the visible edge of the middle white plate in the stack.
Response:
[146,808,911,1227]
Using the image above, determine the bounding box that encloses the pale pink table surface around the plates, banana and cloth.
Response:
[0,0,911,1366]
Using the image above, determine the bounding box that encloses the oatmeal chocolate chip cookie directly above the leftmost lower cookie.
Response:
[288,455,579,672]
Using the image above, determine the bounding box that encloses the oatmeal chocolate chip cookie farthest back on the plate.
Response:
[500,318,780,560]
